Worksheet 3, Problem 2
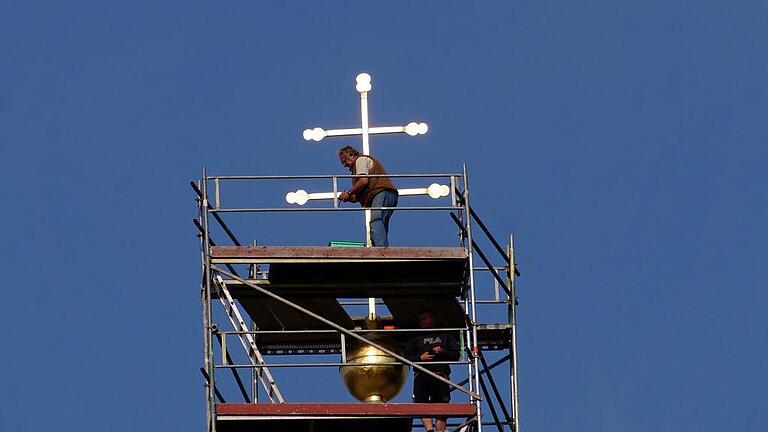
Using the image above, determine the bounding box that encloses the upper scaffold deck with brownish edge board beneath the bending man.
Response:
[211,246,469,298]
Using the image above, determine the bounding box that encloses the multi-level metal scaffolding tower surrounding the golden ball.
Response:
[191,167,520,432]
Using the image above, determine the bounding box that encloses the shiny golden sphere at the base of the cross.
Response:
[339,333,408,403]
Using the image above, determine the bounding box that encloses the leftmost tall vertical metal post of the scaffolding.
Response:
[200,166,216,432]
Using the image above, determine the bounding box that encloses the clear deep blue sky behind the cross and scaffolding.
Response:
[0,0,768,432]
